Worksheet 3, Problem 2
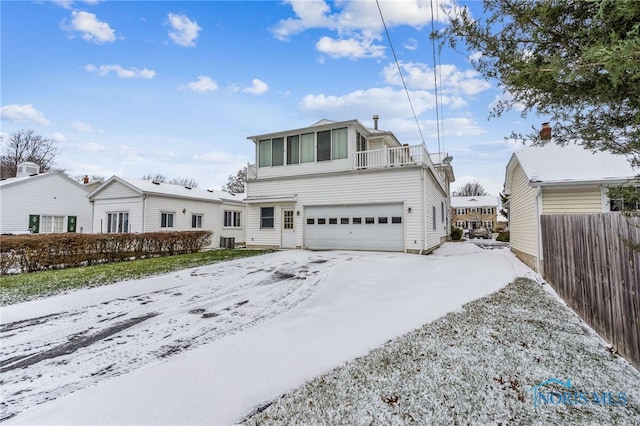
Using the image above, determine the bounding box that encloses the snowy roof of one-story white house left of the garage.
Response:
[89,176,244,203]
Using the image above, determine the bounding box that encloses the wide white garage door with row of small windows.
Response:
[304,204,404,251]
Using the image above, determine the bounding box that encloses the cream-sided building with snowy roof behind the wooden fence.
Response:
[505,144,637,273]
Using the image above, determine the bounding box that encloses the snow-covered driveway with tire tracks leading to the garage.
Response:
[0,243,535,424]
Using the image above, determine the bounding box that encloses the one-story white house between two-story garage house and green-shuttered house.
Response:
[88,176,246,247]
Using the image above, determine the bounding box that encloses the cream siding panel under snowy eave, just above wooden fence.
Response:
[542,187,602,214]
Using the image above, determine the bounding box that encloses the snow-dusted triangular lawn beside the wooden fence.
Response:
[245,278,640,425]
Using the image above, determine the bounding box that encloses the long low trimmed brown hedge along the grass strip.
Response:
[0,231,212,274]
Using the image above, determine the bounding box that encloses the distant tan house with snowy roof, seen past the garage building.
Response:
[451,195,500,231]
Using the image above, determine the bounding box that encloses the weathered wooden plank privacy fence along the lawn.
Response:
[541,213,640,368]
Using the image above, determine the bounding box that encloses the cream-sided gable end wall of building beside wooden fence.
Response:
[509,164,538,257]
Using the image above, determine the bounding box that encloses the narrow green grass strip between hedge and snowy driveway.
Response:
[0,249,269,306]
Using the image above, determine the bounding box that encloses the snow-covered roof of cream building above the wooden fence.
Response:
[507,144,638,186]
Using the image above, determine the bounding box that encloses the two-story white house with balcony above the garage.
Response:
[245,116,454,253]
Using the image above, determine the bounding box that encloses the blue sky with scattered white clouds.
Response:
[0,0,544,195]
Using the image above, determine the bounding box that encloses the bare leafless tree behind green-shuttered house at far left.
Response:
[0,129,58,179]
